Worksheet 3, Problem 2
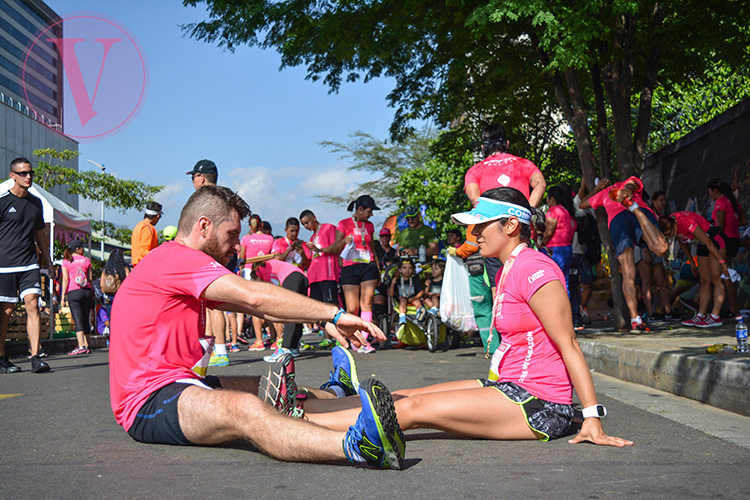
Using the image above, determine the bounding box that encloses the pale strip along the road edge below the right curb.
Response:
[591,372,750,450]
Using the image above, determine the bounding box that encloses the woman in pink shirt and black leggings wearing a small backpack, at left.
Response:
[61,240,94,356]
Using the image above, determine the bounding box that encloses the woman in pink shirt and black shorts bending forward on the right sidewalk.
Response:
[659,212,729,328]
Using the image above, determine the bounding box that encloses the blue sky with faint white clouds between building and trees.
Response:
[47,0,408,238]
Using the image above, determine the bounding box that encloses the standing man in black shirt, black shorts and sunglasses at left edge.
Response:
[0,158,53,373]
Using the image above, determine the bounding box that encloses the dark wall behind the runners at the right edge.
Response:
[641,99,750,216]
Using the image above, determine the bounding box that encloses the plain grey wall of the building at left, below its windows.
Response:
[0,103,78,209]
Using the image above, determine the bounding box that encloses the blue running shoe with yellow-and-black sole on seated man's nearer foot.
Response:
[343,379,406,470]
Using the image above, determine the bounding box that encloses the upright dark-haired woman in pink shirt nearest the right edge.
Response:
[707,179,747,320]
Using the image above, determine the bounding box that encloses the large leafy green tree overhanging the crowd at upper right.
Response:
[184,0,750,326]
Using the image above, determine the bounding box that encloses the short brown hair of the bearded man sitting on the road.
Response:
[177,186,250,235]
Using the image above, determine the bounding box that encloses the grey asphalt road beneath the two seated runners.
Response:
[0,342,750,500]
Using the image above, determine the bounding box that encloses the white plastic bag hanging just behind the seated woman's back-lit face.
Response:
[440,255,477,332]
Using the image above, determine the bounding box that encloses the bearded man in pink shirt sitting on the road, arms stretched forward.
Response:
[110,186,405,469]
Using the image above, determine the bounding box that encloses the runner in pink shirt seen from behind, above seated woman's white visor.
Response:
[464,124,547,206]
